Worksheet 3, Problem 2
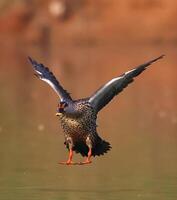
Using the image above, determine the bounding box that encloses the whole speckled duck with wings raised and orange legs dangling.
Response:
[29,56,163,164]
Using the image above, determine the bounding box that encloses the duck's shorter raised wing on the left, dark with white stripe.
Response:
[28,57,72,101]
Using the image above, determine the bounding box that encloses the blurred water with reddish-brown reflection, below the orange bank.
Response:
[0,41,177,200]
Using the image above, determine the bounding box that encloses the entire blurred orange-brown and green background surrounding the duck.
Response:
[0,0,177,200]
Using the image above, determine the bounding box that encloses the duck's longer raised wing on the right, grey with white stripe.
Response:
[89,55,164,112]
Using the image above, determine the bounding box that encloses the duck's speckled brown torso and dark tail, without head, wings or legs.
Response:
[57,99,111,156]
